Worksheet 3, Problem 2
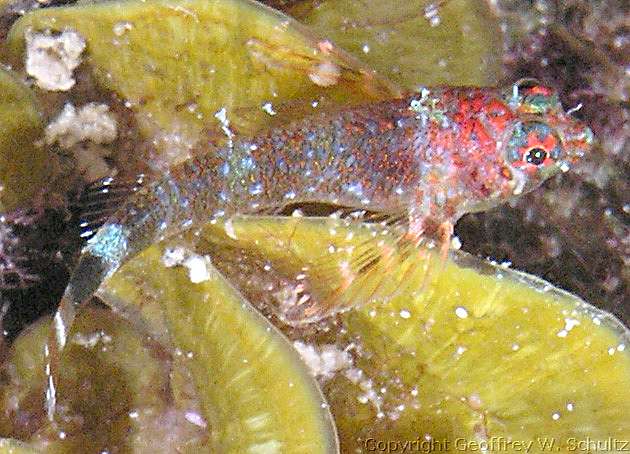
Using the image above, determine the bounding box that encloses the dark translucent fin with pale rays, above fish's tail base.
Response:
[76,174,147,239]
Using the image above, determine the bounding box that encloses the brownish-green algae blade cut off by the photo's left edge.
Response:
[0,69,46,212]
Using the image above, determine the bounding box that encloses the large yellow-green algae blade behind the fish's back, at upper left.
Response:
[7,0,399,154]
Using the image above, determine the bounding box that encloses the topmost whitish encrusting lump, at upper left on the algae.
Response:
[24,30,85,91]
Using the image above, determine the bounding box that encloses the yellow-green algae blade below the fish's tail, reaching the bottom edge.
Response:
[102,246,338,454]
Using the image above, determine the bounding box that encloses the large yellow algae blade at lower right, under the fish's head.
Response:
[202,218,630,452]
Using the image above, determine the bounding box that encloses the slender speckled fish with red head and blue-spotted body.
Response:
[48,80,593,415]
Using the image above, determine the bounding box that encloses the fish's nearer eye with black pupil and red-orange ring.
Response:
[507,121,561,170]
